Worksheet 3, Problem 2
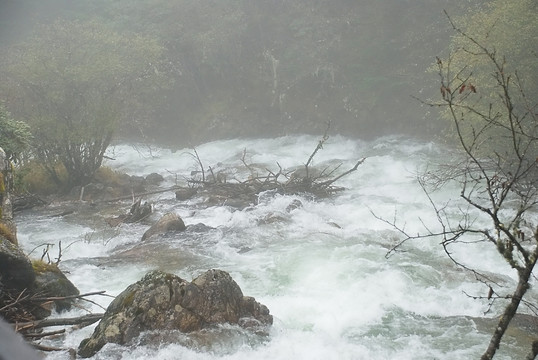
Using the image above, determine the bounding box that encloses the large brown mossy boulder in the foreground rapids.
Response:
[79,270,273,357]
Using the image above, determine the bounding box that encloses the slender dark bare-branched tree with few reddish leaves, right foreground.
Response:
[374,12,538,360]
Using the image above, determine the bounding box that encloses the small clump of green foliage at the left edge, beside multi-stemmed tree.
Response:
[0,105,32,161]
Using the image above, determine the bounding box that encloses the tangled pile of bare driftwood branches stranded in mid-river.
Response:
[104,134,365,222]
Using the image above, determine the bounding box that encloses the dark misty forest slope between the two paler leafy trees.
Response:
[68,0,474,142]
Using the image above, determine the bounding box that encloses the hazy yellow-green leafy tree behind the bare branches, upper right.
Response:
[442,0,538,158]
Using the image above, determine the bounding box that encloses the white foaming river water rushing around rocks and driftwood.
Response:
[17,136,536,360]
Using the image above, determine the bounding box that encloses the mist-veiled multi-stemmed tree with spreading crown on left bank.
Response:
[4,20,169,185]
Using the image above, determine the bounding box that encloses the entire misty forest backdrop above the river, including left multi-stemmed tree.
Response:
[0,0,538,185]
